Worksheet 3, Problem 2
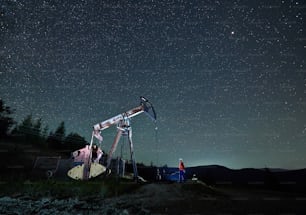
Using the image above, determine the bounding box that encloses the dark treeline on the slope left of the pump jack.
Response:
[0,99,87,154]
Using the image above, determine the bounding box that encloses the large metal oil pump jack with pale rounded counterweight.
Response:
[68,96,156,180]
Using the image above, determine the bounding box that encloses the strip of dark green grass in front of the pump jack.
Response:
[0,179,141,199]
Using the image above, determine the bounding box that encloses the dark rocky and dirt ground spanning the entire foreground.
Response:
[0,182,306,215]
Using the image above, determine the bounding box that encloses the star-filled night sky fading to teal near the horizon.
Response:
[0,0,306,169]
